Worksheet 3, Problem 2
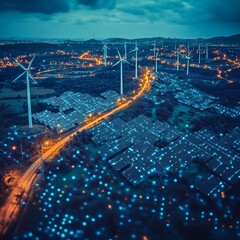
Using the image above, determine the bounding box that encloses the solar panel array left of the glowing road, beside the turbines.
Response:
[33,91,120,132]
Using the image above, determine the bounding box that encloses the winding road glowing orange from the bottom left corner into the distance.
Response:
[0,69,152,238]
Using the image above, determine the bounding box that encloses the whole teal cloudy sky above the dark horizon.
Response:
[0,0,240,39]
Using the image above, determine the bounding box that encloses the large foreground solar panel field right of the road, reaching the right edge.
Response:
[90,115,240,198]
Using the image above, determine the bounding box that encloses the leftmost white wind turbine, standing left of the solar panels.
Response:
[12,56,37,128]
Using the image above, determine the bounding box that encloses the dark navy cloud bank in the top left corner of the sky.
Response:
[0,0,70,14]
